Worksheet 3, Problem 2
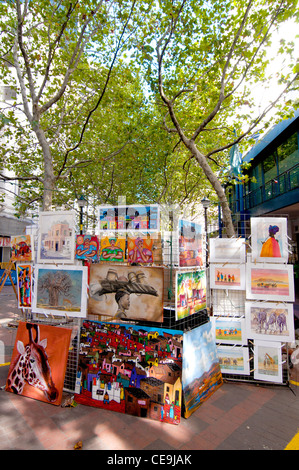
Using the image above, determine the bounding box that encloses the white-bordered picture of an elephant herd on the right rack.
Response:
[245,302,295,343]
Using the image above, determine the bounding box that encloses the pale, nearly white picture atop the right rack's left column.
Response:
[209,238,246,263]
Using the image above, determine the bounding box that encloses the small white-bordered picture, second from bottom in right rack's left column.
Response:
[211,317,247,345]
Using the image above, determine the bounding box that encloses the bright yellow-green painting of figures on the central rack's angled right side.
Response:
[175,269,207,320]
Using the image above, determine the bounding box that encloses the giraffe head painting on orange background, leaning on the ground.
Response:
[5,322,71,405]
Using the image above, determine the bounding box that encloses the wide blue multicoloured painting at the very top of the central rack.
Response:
[99,204,160,232]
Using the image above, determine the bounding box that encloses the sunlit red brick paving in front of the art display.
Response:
[0,287,299,455]
